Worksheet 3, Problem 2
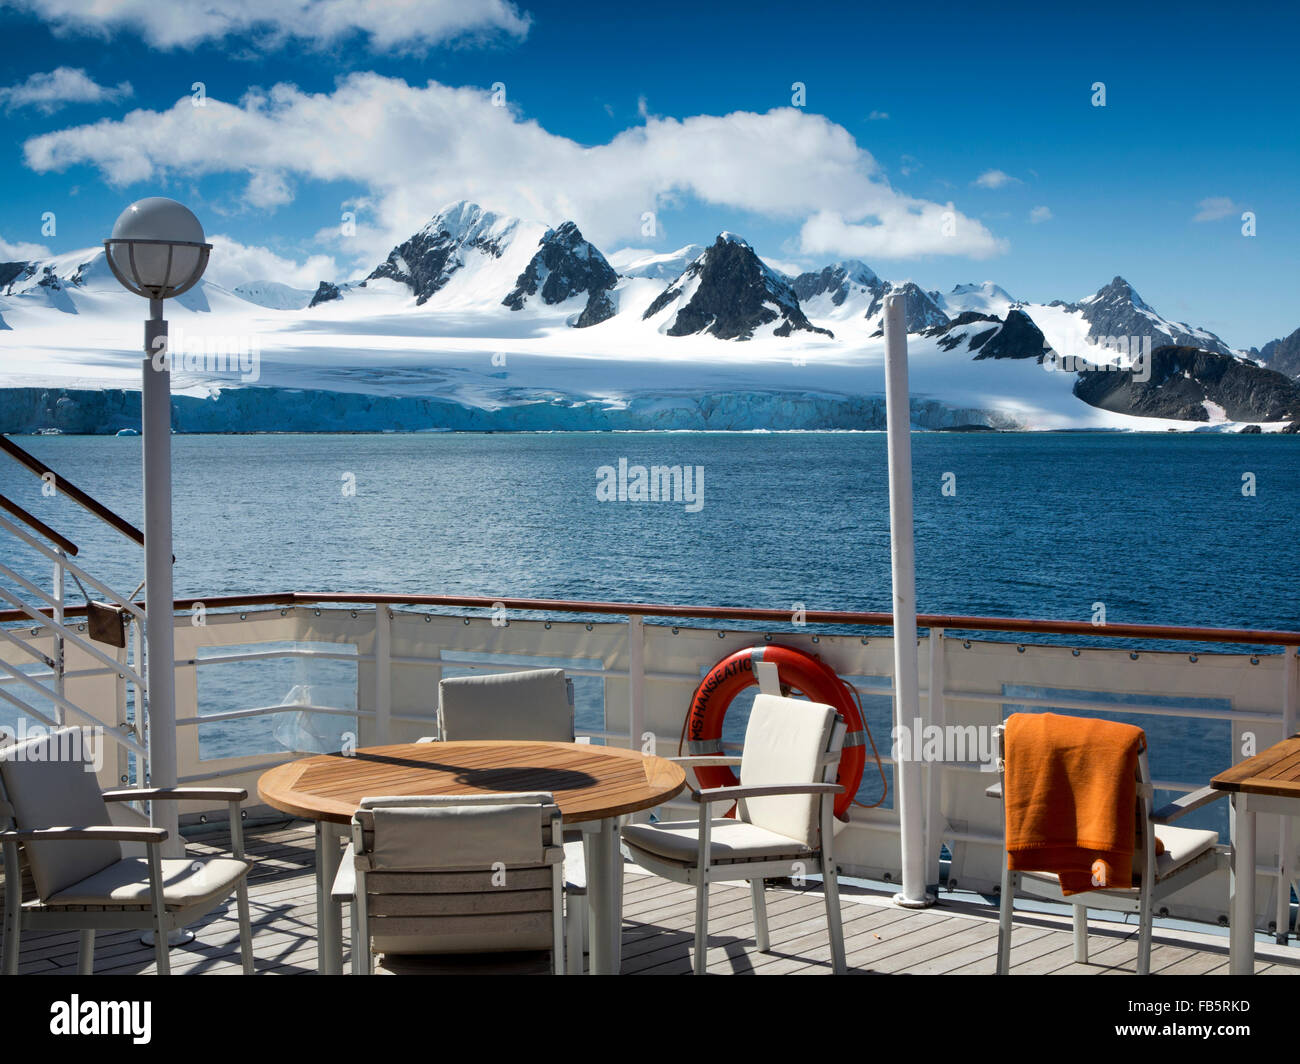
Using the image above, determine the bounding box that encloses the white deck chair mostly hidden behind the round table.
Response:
[420,669,592,974]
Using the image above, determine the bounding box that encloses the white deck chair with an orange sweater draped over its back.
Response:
[985,726,1225,976]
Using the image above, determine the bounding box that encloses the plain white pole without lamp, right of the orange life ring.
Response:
[885,293,935,909]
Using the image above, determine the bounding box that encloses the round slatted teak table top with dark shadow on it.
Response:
[257,741,686,823]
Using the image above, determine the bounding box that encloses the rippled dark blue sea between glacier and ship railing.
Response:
[0,433,1300,827]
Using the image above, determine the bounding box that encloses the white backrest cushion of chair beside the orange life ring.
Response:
[738,695,836,847]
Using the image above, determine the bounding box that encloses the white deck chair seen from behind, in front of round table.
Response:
[334,793,564,974]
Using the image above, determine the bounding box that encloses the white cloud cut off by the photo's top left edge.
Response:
[9,0,530,51]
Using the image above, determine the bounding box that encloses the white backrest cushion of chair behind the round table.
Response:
[438,669,573,743]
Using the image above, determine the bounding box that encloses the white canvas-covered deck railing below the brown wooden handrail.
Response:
[0,596,1300,929]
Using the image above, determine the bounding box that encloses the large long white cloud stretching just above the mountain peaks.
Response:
[23,73,1002,258]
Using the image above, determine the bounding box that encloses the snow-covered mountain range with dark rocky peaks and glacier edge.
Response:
[0,202,1300,431]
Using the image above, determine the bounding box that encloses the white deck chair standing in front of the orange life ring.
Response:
[623,695,846,976]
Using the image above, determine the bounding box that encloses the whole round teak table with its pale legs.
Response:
[257,741,686,974]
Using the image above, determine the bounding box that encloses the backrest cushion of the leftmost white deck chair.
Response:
[0,728,122,900]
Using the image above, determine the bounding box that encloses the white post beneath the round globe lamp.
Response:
[140,299,185,856]
